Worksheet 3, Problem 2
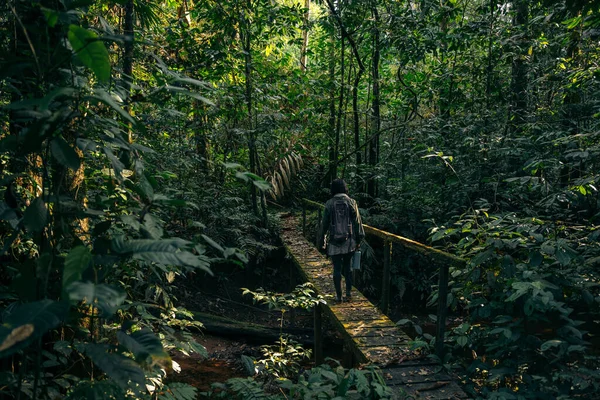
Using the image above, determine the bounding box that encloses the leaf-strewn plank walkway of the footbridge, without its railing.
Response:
[281,215,467,399]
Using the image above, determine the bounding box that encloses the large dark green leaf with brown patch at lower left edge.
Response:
[0,300,68,358]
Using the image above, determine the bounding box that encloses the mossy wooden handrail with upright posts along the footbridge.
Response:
[302,199,465,358]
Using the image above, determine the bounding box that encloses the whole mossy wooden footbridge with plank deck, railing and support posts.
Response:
[281,200,467,399]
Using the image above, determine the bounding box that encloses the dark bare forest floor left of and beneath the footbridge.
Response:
[166,260,344,392]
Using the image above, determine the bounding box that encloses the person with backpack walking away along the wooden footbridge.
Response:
[319,179,365,302]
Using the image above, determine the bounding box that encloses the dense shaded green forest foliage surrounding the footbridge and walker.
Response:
[0,0,600,400]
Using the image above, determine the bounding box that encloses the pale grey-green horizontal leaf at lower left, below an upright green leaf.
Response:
[67,282,127,317]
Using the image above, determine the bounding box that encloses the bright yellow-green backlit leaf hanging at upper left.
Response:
[68,25,110,82]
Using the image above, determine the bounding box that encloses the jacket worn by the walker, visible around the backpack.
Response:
[319,193,365,256]
